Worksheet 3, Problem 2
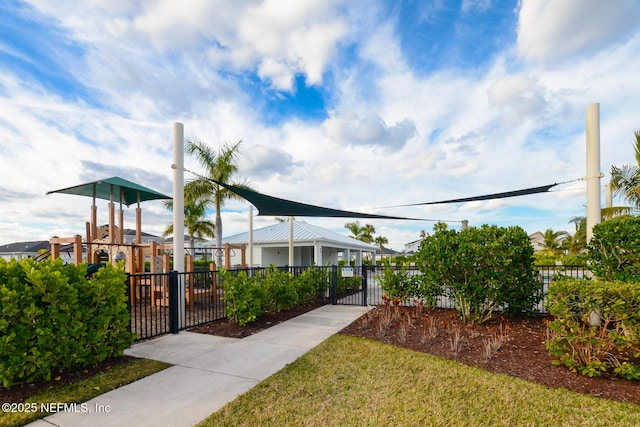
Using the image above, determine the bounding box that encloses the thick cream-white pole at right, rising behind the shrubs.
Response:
[586,103,601,242]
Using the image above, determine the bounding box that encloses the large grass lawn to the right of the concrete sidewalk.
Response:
[199,335,640,426]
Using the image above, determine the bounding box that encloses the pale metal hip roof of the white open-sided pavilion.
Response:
[222,220,377,251]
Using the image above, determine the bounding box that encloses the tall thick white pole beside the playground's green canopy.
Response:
[172,122,185,328]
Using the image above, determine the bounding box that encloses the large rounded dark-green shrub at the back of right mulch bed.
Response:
[415,225,542,323]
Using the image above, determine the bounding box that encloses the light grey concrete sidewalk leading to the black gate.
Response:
[30,305,367,427]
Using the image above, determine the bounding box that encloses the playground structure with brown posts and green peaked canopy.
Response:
[47,177,246,307]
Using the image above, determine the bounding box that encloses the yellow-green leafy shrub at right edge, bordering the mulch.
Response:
[546,279,640,380]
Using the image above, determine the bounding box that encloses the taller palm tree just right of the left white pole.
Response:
[184,140,252,265]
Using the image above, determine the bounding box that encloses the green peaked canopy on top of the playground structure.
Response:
[47,176,171,206]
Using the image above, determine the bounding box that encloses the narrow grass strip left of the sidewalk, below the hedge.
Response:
[0,359,171,427]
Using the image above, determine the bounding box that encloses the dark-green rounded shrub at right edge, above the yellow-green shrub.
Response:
[587,216,640,282]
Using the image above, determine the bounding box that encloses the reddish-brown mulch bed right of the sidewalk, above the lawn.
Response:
[342,306,640,405]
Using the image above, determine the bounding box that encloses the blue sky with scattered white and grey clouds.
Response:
[0,0,640,250]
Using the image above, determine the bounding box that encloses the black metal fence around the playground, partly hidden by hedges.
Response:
[127,265,591,340]
